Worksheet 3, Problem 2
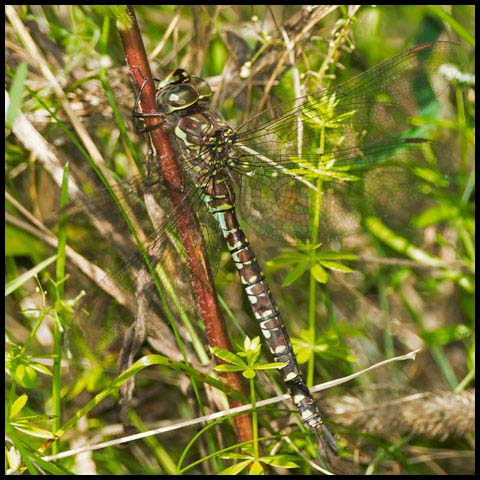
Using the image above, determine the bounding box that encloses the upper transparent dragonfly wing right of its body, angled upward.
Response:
[237,42,456,146]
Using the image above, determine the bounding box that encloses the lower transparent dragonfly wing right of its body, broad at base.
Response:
[235,139,448,246]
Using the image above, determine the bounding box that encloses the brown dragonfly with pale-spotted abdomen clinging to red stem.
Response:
[59,42,454,462]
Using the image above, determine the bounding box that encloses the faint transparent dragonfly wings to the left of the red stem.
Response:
[54,166,218,368]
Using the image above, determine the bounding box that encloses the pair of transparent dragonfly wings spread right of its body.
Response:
[229,42,455,244]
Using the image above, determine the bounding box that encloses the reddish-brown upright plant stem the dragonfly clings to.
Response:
[120,6,252,441]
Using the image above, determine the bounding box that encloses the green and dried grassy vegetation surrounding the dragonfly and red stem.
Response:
[5,5,475,475]
